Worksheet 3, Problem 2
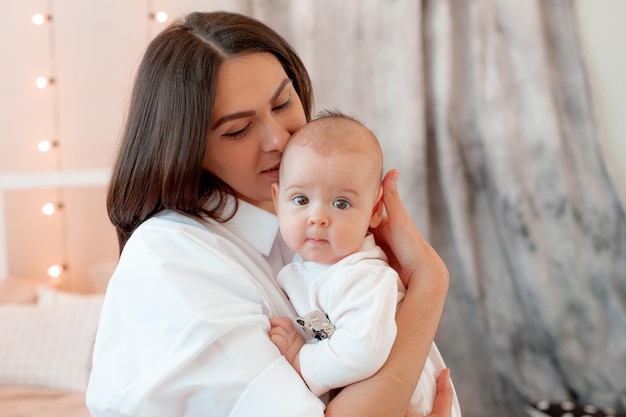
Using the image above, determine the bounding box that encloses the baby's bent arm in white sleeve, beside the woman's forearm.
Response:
[298,260,401,396]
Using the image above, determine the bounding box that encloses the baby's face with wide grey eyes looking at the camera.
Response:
[272,146,381,264]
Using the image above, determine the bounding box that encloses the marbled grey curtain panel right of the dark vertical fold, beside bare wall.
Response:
[423,0,626,416]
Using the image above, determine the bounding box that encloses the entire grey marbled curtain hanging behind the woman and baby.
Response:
[250,0,626,417]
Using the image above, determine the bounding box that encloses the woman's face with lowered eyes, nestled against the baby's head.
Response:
[202,53,306,212]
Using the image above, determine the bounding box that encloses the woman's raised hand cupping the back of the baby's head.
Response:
[372,169,449,291]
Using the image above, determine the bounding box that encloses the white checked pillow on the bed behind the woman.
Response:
[0,289,102,391]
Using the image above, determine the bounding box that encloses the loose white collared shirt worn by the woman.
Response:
[87,201,324,417]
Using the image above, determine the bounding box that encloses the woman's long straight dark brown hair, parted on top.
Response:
[107,12,313,252]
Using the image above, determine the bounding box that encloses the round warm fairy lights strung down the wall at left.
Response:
[30,4,169,283]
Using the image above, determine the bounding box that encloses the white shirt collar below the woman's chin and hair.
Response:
[225,200,279,256]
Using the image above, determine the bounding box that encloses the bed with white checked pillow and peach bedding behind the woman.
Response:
[0,278,103,417]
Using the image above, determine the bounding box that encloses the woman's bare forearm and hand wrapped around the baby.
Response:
[326,170,452,417]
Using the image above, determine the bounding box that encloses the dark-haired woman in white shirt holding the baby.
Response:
[87,12,451,417]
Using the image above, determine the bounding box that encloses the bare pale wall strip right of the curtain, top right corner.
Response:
[576,0,626,205]
